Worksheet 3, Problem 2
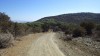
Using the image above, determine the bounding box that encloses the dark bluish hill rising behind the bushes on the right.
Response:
[38,12,100,23]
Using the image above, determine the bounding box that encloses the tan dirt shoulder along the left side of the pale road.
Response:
[0,34,40,56]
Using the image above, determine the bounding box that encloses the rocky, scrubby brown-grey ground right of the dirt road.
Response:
[55,33,100,56]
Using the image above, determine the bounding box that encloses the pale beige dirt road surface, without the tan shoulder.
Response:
[27,33,64,56]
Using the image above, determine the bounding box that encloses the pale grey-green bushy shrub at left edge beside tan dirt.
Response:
[0,33,14,48]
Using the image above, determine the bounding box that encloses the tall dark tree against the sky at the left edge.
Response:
[0,12,11,33]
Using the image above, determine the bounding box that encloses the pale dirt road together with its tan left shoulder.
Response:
[1,33,64,56]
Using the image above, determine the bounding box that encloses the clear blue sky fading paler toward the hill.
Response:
[0,0,100,22]
